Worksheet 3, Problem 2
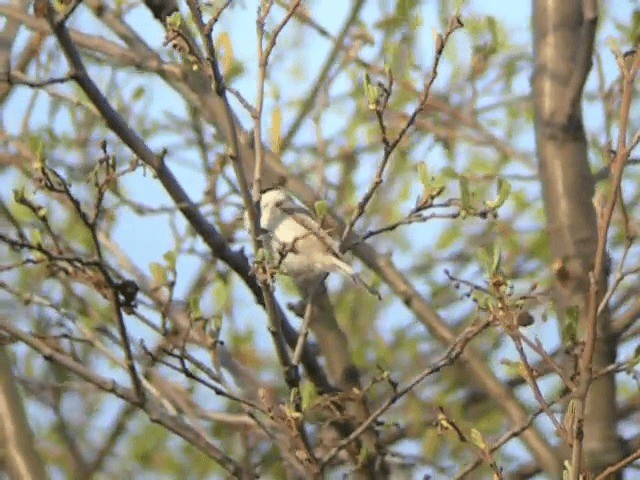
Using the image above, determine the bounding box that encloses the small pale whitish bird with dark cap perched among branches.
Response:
[245,187,380,297]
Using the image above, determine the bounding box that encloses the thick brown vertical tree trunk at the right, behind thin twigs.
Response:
[533,0,622,473]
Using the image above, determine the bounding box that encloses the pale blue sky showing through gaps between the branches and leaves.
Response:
[2,0,633,476]
